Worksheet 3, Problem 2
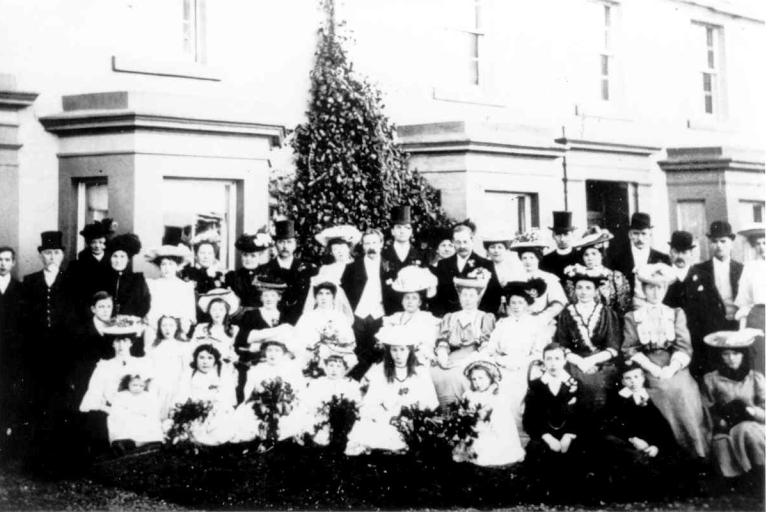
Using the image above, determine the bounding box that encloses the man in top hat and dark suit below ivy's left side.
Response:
[256,220,317,325]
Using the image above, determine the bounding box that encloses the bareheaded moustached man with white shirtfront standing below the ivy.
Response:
[341,229,394,379]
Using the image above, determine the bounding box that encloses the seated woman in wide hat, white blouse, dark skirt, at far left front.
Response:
[79,321,154,451]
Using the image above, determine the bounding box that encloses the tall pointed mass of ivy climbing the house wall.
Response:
[272,0,449,258]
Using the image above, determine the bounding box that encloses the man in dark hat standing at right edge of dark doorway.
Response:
[606,212,670,305]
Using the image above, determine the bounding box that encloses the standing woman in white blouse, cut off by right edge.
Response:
[734,223,768,374]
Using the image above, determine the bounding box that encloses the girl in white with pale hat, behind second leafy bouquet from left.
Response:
[231,340,306,443]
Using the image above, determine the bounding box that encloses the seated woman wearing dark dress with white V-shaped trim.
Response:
[553,274,621,413]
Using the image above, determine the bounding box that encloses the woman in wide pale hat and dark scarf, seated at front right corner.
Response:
[704,328,765,477]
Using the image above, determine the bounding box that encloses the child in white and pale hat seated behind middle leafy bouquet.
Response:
[302,354,362,446]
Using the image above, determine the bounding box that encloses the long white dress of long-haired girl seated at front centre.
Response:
[345,363,438,455]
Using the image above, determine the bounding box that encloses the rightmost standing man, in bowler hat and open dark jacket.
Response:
[685,221,743,377]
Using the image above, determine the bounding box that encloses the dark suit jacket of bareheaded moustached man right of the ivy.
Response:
[430,252,501,317]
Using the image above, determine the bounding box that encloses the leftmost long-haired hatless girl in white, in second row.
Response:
[147,315,192,418]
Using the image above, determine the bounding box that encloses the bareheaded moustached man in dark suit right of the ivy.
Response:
[431,224,501,317]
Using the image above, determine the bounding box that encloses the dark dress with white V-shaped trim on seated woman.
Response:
[554,304,621,412]
